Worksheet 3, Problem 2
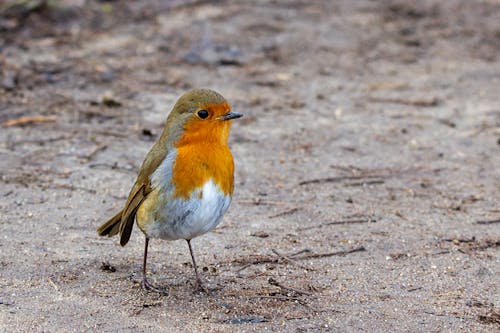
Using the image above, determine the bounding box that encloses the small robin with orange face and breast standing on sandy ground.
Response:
[97,89,243,292]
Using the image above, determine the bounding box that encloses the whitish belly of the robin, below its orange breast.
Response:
[143,180,231,240]
